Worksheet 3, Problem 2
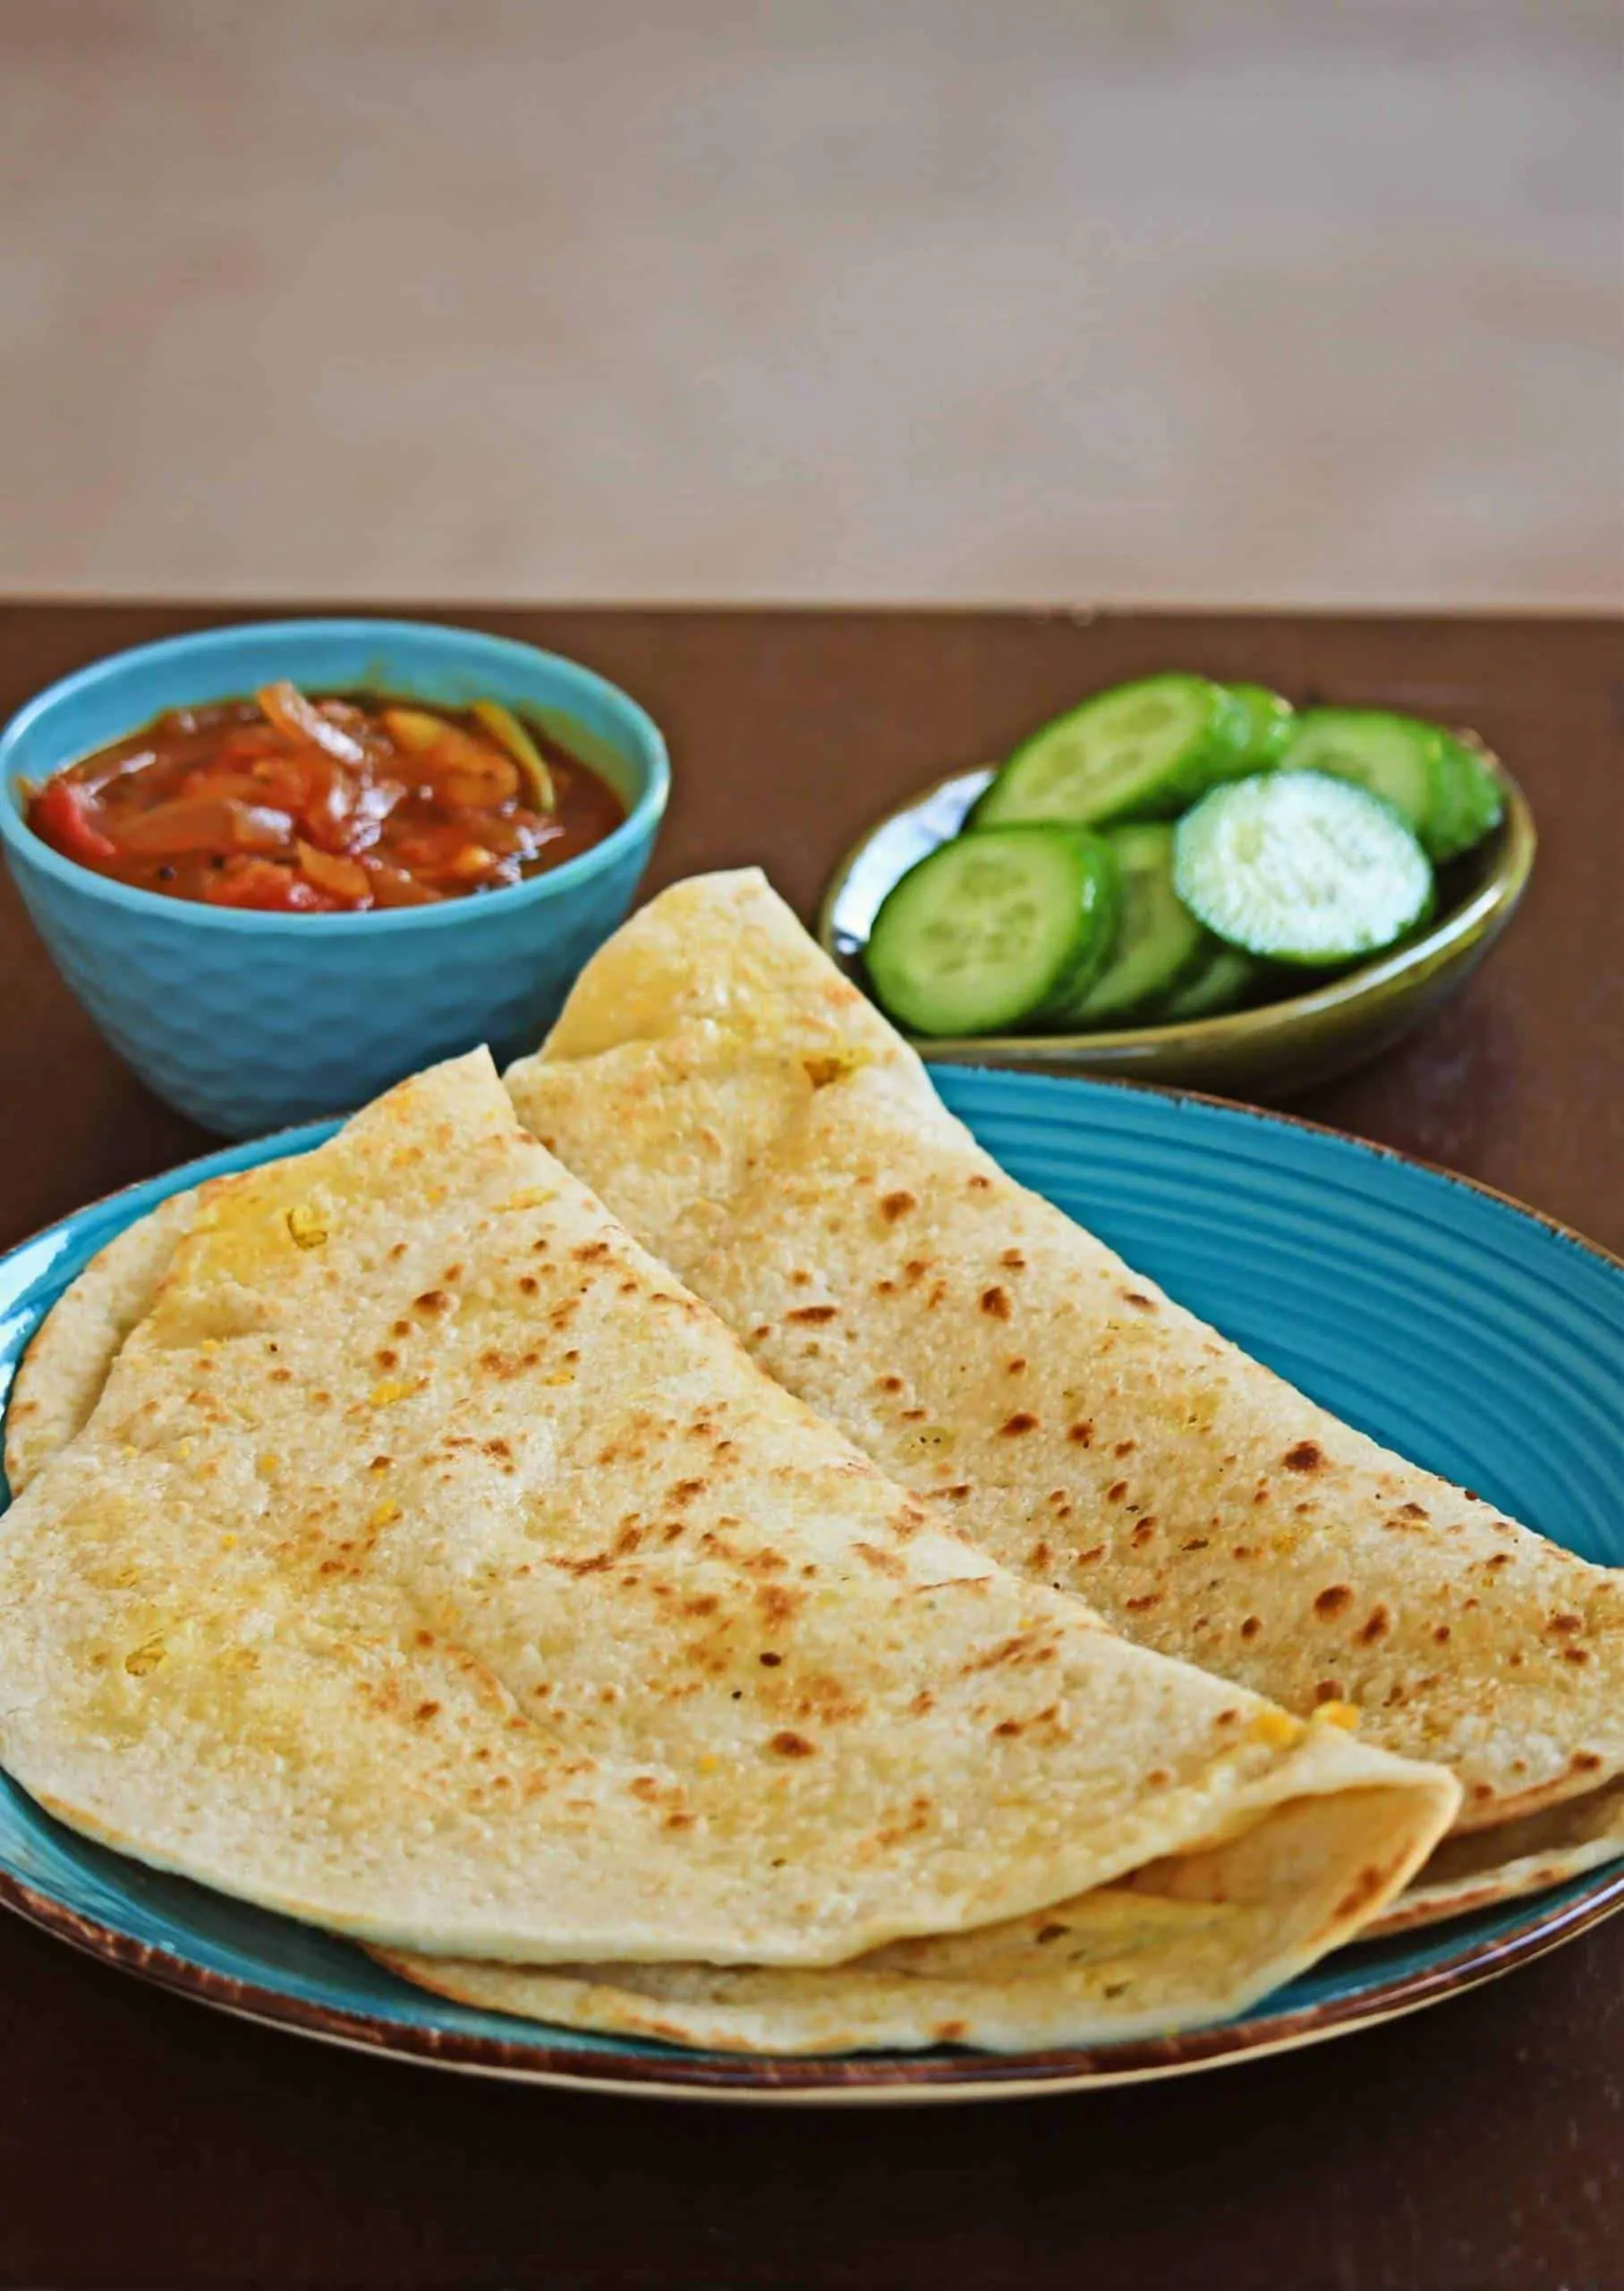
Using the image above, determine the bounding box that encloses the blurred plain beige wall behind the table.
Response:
[0,0,1624,607]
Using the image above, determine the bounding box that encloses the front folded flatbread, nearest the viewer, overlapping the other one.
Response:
[0,1054,1457,2046]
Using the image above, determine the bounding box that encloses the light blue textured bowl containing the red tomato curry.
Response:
[0,621,671,1137]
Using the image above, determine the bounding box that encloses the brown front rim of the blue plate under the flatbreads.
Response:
[0,1869,1624,2094]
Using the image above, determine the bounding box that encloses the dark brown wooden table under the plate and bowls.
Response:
[0,607,1624,2291]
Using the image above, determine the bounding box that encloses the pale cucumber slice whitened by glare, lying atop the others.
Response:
[1173,770,1432,967]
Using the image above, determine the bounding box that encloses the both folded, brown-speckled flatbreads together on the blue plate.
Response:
[0,873,1624,2050]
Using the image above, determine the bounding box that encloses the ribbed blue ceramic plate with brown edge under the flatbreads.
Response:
[0,1068,1624,2101]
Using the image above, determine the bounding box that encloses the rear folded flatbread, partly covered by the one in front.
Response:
[494,871,1624,1922]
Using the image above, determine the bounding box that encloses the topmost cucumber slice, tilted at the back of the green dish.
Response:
[971,676,1248,830]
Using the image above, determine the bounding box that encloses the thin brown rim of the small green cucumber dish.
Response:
[813,755,1539,1068]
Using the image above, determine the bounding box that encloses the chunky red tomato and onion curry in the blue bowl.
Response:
[28,683,625,914]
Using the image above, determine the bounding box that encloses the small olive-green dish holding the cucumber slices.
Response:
[818,749,1535,1097]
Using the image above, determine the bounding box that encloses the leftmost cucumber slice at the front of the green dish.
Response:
[863,825,1116,1034]
